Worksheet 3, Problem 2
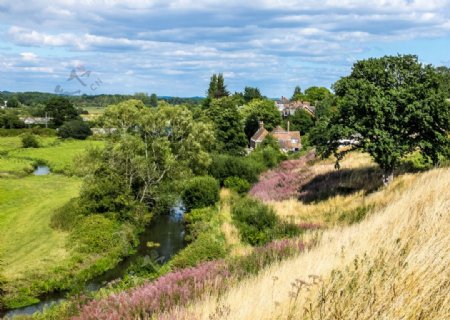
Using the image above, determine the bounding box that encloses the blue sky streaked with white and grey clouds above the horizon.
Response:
[0,0,450,97]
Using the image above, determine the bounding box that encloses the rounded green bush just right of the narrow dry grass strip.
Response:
[231,197,278,245]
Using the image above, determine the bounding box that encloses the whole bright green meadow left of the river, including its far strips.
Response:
[0,136,103,307]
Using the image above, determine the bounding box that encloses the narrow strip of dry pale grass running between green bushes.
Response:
[219,189,251,255]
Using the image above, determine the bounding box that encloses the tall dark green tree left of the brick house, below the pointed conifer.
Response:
[206,97,247,154]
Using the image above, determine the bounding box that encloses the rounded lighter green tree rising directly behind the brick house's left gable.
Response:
[240,99,281,139]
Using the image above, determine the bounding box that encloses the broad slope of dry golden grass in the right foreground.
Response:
[170,169,450,319]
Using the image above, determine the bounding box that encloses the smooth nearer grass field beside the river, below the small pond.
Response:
[0,175,81,281]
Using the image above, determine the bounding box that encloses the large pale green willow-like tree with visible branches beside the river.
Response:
[81,100,214,219]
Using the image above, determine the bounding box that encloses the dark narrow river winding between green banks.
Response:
[0,206,186,319]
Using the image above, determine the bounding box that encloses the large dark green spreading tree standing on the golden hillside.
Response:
[318,55,450,183]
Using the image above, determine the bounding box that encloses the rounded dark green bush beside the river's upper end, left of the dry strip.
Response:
[182,176,220,211]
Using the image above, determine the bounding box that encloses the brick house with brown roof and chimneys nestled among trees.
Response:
[250,121,302,152]
